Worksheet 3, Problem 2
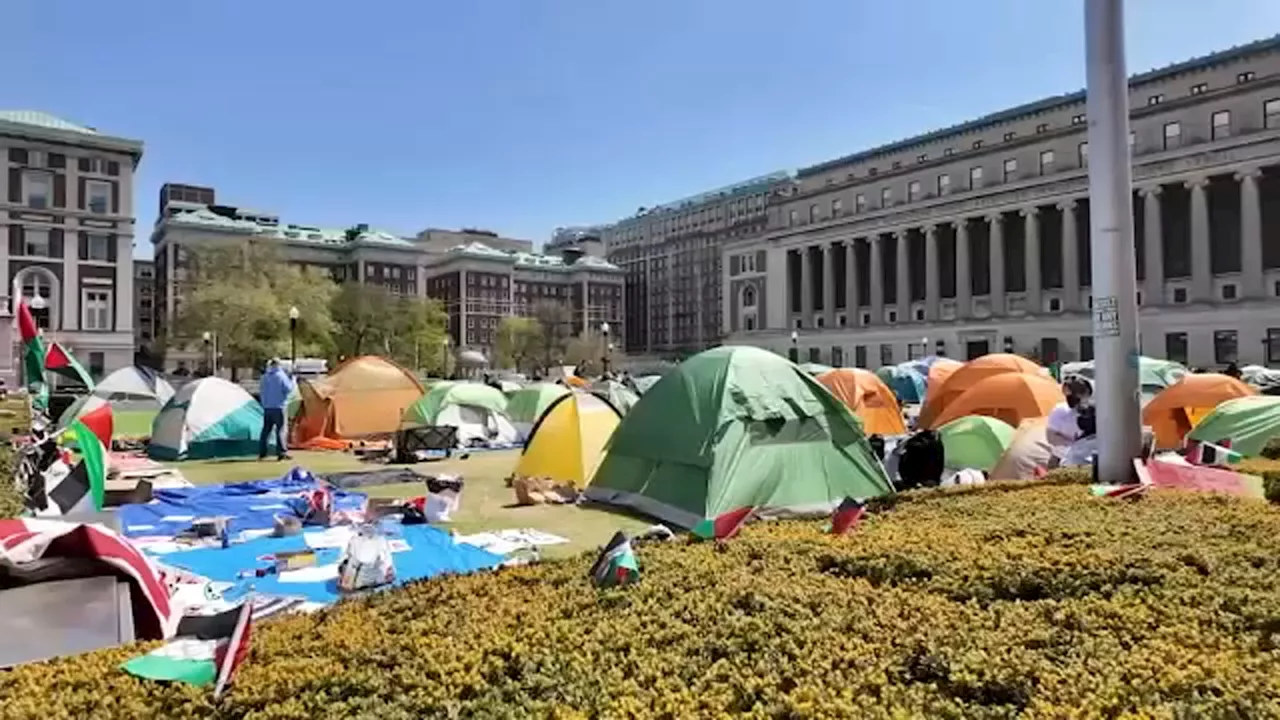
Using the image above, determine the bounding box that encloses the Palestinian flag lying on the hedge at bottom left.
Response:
[122,597,253,698]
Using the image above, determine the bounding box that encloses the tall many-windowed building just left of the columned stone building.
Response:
[598,173,791,356]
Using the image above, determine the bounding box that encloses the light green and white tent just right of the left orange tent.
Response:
[401,382,520,446]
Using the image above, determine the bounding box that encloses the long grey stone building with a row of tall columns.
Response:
[722,38,1280,368]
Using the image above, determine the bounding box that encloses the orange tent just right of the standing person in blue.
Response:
[293,355,425,443]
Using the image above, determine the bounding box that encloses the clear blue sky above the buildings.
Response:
[0,0,1280,256]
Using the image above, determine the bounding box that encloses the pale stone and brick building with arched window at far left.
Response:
[0,110,142,377]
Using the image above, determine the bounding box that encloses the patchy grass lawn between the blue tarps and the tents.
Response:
[169,450,652,557]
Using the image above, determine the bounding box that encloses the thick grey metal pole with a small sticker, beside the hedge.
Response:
[1084,0,1142,483]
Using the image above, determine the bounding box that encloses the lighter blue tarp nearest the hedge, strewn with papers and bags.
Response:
[159,525,503,603]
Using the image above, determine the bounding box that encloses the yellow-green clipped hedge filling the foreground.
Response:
[0,474,1280,720]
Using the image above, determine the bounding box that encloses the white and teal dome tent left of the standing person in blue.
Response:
[147,378,262,460]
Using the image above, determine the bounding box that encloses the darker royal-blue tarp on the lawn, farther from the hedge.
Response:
[118,468,367,537]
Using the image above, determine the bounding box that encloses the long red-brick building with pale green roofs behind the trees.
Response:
[151,183,622,368]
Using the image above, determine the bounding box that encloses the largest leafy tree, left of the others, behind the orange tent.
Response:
[177,241,335,377]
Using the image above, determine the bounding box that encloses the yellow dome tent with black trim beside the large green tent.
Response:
[516,392,622,487]
